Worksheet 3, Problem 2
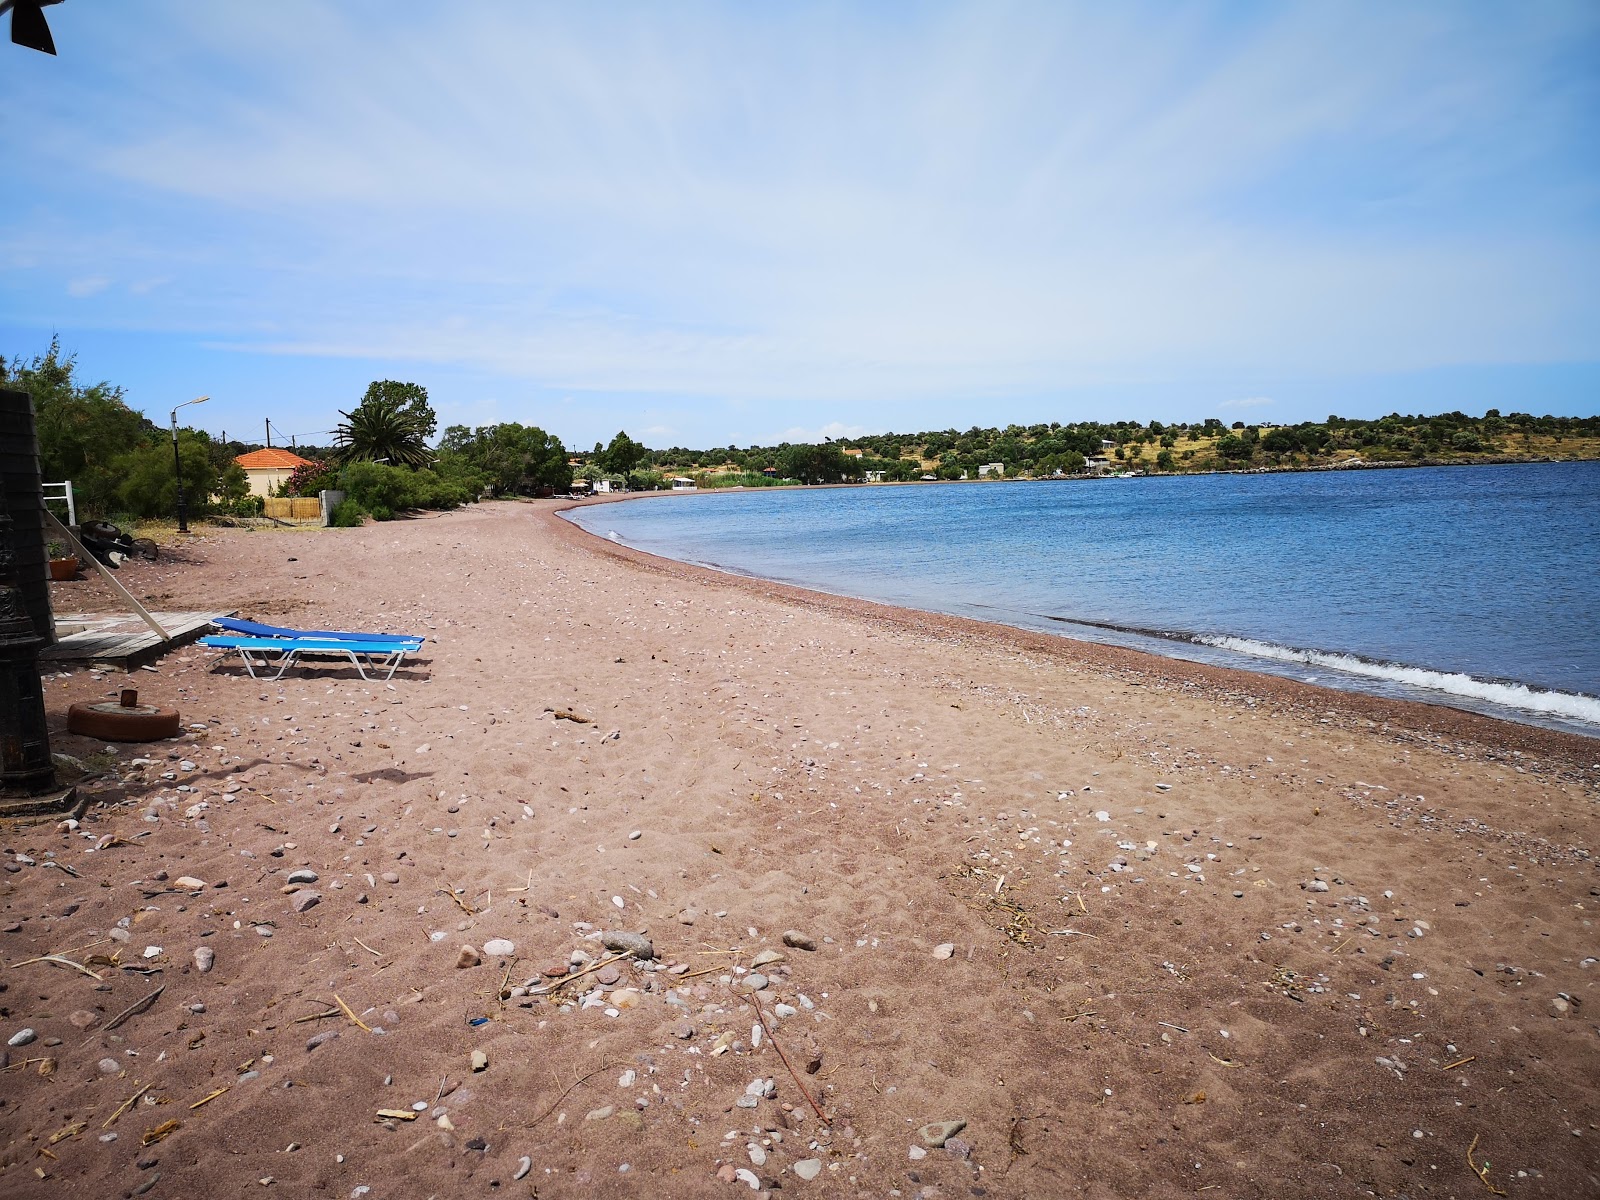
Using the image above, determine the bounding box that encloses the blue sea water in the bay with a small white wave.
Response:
[570,462,1600,736]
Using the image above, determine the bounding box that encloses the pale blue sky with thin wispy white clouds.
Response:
[0,0,1600,448]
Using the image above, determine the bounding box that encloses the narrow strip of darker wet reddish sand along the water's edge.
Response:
[544,499,1600,779]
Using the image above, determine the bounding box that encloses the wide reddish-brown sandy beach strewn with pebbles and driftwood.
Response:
[0,502,1600,1200]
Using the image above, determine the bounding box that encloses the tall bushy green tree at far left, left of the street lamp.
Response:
[0,338,159,518]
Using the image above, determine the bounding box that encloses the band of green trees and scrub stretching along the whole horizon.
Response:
[0,339,1600,525]
